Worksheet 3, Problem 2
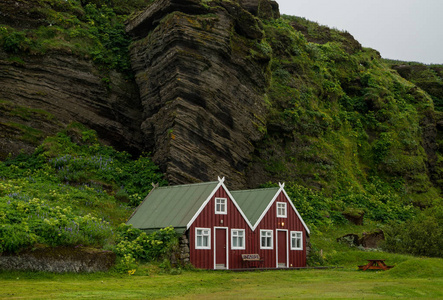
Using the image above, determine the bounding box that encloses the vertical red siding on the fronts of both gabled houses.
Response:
[189,187,306,269]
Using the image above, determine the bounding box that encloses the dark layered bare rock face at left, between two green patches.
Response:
[0,52,141,159]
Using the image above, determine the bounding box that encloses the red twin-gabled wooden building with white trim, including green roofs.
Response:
[127,178,309,269]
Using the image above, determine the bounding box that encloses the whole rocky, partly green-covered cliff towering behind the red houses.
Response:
[0,0,443,198]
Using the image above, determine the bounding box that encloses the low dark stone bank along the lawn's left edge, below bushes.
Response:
[0,247,116,273]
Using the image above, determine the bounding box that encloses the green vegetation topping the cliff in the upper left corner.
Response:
[0,0,150,75]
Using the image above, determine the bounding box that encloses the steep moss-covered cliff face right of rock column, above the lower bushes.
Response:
[250,12,443,209]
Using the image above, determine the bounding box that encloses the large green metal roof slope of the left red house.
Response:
[127,181,219,229]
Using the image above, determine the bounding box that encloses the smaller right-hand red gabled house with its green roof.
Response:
[232,184,309,268]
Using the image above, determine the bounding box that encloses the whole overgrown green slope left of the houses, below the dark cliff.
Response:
[0,124,165,252]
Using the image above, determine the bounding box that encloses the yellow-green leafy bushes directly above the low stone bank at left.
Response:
[0,193,113,253]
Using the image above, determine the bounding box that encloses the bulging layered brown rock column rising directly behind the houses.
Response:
[127,0,270,187]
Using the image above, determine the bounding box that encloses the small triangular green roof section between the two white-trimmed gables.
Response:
[231,187,279,226]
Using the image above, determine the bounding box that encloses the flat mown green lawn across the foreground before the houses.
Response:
[0,257,443,299]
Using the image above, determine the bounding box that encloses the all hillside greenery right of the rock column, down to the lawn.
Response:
[254,16,442,256]
